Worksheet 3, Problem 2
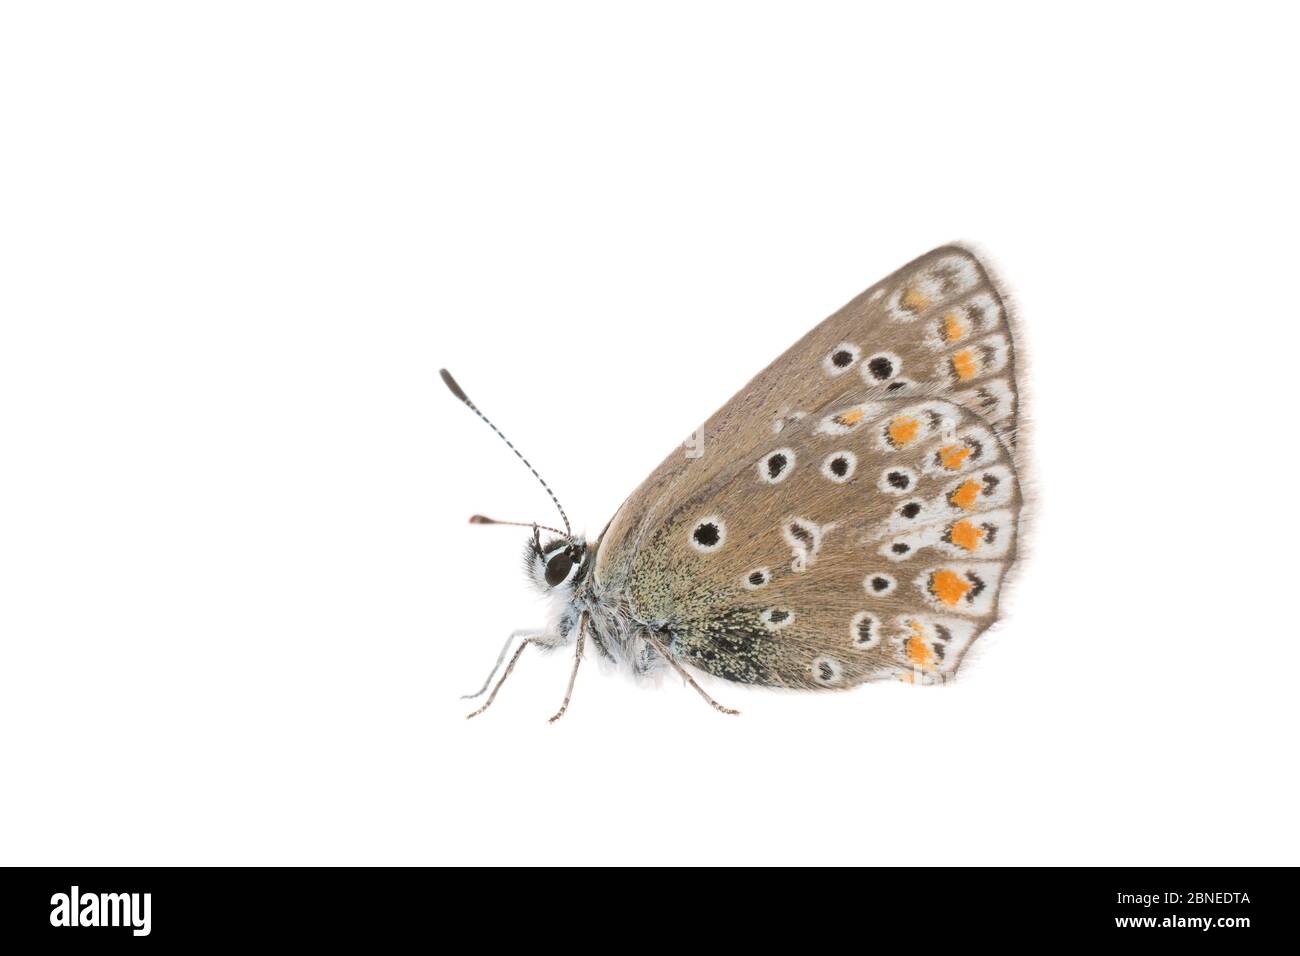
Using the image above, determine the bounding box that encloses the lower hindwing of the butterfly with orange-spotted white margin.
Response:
[628,398,1019,687]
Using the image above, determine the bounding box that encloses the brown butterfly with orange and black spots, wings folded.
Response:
[441,246,1022,722]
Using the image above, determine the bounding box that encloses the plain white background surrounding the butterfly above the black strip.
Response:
[0,3,1300,865]
